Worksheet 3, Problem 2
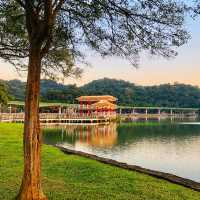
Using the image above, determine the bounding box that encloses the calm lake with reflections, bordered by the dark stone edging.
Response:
[43,122,200,182]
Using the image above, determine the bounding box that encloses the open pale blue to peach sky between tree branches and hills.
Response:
[0,16,200,87]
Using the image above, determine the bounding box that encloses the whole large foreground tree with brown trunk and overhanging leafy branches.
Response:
[0,0,189,200]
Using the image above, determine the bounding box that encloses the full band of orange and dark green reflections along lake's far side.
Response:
[43,123,200,148]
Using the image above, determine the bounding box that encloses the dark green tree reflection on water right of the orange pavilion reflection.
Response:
[117,123,200,145]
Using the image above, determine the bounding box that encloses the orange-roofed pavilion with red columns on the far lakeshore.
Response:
[77,95,117,117]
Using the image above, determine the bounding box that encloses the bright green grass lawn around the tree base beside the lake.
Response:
[0,123,200,200]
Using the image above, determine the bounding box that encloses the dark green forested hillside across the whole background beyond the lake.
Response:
[1,78,200,107]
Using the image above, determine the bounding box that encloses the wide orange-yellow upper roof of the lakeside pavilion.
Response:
[76,95,117,102]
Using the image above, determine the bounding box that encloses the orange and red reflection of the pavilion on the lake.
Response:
[63,123,117,148]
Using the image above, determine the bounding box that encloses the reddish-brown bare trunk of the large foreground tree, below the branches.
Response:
[17,48,47,200]
